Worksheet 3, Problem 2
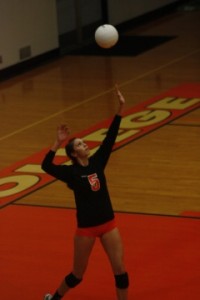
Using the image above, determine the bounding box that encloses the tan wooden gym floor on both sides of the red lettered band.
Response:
[0,5,200,218]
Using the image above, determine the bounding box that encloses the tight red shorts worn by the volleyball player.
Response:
[76,219,116,237]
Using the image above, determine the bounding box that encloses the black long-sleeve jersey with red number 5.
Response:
[42,115,121,227]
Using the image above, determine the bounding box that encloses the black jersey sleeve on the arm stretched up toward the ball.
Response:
[93,115,121,168]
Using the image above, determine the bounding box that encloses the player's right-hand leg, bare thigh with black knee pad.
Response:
[101,228,129,300]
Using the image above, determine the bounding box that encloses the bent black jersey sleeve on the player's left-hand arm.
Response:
[42,150,70,183]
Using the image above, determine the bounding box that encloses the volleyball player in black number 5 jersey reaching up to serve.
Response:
[42,86,129,300]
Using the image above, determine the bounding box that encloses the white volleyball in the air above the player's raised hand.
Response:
[95,24,119,48]
